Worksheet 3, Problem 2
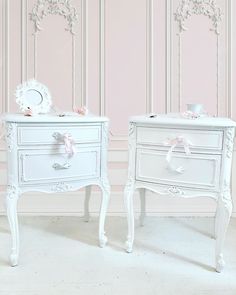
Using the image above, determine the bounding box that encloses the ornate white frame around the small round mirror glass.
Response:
[15,79,52,114]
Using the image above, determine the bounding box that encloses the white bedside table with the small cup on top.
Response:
[125,114,236,272]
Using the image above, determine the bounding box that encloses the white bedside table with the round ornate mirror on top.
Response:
[3,114,110,266]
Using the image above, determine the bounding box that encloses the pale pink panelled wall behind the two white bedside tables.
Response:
[0,0,236,212]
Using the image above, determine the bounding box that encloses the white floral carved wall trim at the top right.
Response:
[174,0,223,35]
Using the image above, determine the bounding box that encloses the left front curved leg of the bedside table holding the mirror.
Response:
[6,186,19,266]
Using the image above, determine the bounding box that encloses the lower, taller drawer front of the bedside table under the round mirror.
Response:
[19,147,100,185]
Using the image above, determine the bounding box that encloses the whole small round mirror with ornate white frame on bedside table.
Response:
[15,80,52,114]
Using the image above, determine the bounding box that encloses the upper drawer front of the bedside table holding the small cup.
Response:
[137,127,223,151]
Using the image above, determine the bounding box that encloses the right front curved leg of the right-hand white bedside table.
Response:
[216,192,232,272]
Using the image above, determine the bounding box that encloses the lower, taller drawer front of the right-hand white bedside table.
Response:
[136,149,221,190]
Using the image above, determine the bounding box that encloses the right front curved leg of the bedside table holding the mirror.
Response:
[99,181,110,248]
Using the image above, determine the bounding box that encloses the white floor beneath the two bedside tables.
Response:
[0,216,236,295]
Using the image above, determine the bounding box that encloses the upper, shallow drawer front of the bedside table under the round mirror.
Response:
[18,125,101,145]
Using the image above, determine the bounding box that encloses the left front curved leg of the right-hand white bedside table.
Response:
[124,184,134,253]
